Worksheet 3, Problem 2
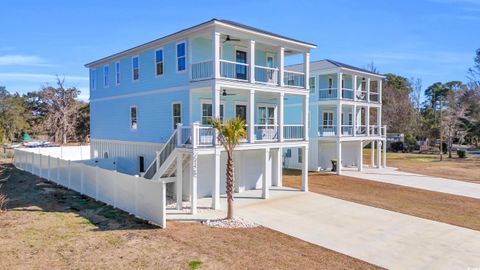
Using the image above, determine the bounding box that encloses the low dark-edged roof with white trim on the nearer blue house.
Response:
[85,18,317,67]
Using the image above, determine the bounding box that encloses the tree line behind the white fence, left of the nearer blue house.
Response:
[0,76,90,144]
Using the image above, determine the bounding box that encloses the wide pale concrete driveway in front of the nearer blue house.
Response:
[173,189,480,269]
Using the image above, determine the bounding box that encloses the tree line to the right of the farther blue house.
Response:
[382,49,480,153]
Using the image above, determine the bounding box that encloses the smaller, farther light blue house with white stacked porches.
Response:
[284,60,386,174]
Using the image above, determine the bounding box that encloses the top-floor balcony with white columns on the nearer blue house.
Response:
[190,32,309,88]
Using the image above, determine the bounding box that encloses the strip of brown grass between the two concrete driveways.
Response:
[283,170,480,231]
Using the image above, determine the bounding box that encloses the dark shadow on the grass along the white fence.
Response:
[0,162,158,231]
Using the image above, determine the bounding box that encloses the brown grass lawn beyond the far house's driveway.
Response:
[363,149,480,183]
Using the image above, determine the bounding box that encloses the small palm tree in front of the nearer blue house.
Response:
[212,117,247,219]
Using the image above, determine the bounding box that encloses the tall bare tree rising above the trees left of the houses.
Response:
[39,76,80,144]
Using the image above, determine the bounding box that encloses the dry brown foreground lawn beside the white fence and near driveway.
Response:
[0,161,377,269]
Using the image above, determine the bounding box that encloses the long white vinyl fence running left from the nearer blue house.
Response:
[14,147,166,228]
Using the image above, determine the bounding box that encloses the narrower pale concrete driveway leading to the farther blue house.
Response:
[342,167,480,199]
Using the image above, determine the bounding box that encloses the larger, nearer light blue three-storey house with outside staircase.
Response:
[86,19,315,213]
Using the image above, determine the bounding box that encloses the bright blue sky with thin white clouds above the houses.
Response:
[0,0,480,99]
